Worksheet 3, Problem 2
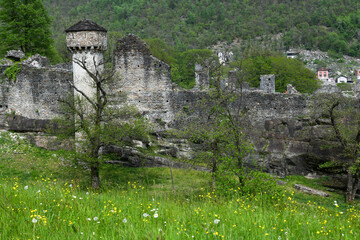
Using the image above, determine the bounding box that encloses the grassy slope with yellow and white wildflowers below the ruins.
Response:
[0,134,360,239]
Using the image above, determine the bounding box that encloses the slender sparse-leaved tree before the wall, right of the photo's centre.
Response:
[177,63,253,192]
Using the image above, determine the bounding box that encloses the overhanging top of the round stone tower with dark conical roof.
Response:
[65,19,107,52]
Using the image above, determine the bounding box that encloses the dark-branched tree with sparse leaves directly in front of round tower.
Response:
[56,56,150,190]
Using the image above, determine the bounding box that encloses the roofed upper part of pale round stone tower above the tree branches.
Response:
[65,19,107,97]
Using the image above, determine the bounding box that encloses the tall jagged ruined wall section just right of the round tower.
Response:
[112,35,175,123]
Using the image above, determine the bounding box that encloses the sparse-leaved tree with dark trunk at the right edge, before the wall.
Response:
[312,93,360,203]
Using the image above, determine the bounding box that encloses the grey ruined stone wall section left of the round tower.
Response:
[0,65,72,131]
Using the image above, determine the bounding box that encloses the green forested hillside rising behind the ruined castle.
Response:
[44,0,360,56]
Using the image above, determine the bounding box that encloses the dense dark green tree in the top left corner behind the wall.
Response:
[0,0,59,62]
